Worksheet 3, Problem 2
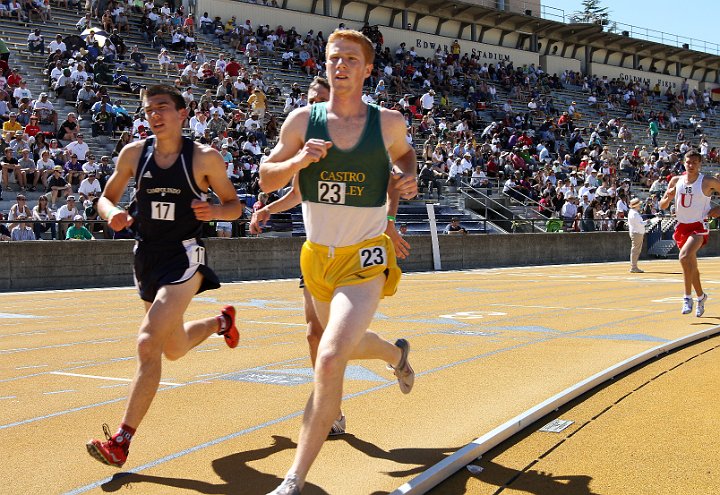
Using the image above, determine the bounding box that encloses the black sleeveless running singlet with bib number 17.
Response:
[131,137,207,244]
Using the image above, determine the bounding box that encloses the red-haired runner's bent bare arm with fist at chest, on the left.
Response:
[260,107,332,192]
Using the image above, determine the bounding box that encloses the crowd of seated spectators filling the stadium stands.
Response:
[0,0,720,237]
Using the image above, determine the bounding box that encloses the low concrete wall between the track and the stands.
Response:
[0,232,720,292]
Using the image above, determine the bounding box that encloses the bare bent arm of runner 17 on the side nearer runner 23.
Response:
[192,146,242,222]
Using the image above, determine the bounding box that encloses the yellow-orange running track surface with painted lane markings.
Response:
[0,259,720,495]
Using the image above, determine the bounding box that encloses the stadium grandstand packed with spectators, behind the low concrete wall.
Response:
[0,0,720,248]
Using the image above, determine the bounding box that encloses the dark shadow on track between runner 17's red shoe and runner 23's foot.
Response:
[102,435,327,495]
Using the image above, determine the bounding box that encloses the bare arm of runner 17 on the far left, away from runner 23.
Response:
[98,141,145,231]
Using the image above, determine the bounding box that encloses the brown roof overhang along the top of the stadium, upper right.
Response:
[352,0,720,70]
